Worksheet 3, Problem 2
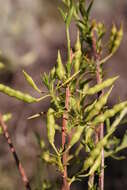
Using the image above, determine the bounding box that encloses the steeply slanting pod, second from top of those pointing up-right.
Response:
[85,87,112,122]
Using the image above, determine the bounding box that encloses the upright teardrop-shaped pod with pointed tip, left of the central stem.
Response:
[56,50,66,80]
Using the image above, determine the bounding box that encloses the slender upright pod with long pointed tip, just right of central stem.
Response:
[74,32,82,73]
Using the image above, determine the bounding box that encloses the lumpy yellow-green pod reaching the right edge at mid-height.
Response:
[92,101,127,126]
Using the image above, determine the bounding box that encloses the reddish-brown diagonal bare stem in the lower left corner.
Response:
[0,113,31,190]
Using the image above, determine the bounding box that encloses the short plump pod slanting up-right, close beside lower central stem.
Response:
[67,126,84,149]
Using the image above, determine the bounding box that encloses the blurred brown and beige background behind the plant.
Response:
[0,0,127,190]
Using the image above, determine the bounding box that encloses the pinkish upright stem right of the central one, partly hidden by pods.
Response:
[92,31,104,190]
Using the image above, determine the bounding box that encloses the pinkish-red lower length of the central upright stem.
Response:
[62,86,70,190]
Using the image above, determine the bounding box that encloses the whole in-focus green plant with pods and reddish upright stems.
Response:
[0,0,127,190]
